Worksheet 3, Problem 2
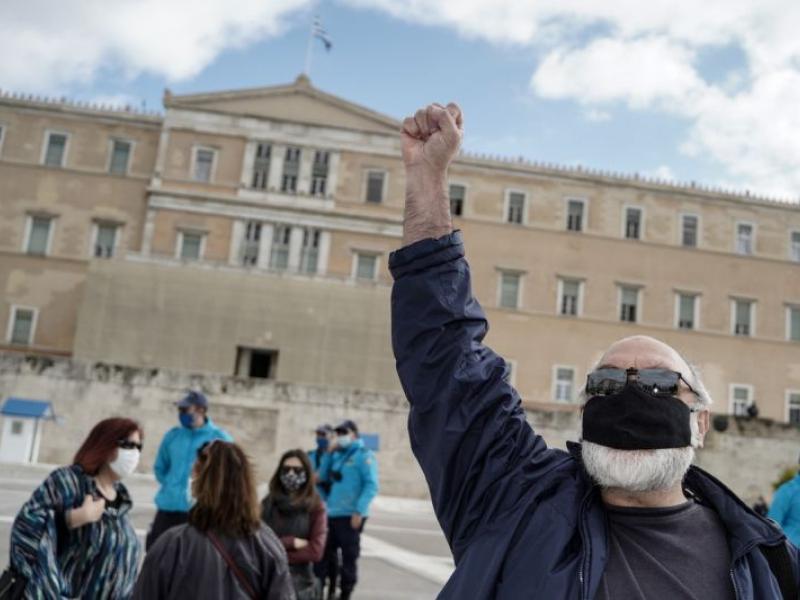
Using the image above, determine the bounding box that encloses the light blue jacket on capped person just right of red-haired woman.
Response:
[153,419,233,512]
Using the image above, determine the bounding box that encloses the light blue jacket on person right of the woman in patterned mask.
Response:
[319,440,378,517]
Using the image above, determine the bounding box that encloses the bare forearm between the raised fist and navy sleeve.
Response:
[403,172,453,246]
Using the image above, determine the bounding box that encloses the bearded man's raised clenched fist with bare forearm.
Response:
[401,103,464,246]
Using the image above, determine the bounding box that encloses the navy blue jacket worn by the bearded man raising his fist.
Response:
[389,232,800,600]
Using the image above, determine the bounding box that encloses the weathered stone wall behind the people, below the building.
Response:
[0,354,800,502]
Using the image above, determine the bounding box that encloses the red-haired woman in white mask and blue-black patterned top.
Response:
[5,418,142,600]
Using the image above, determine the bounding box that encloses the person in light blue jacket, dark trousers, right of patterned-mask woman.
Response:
[316,420,378,600]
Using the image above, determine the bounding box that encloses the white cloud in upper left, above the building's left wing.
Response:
[0,0,312,92]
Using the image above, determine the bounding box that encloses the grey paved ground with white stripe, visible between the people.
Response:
[0,463,453,600]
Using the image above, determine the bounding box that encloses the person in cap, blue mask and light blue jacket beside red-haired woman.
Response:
[145,391,233,550]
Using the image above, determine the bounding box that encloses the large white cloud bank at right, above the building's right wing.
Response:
[342,0,800,198]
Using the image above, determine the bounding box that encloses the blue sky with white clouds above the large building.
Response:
[0,0,800,197]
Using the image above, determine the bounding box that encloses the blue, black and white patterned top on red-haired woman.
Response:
[10,465,142,600]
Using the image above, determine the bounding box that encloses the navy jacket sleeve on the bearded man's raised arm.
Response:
[389,231,570,560]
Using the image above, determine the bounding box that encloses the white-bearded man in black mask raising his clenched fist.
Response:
[390,104,800,600]
